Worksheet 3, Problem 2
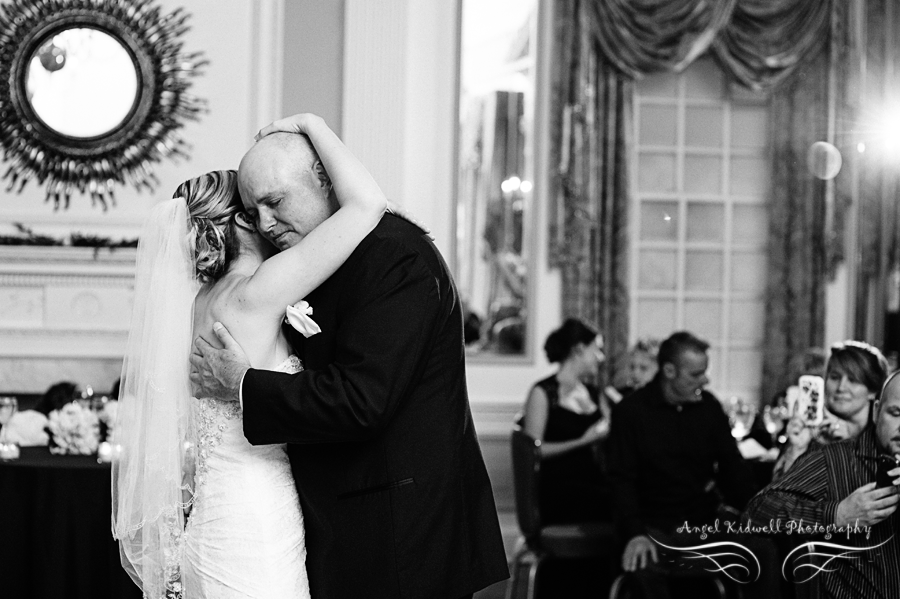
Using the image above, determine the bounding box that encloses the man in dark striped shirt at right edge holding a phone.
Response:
[745,375,900,599]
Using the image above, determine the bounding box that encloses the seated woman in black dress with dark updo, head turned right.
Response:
[523,318,609,524]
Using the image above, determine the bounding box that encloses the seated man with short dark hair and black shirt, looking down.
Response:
[608,332,778,598]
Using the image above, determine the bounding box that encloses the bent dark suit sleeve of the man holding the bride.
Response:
[242,239,441,445]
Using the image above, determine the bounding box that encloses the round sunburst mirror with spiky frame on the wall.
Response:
[0,0,206,209]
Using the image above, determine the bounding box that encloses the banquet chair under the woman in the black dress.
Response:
[506,424,615,599]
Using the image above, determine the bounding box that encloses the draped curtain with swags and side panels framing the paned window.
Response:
[550,0,836,393]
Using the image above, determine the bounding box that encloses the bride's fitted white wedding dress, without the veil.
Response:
[182,356,309,599]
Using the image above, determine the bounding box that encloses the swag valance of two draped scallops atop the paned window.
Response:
[588,0,831,89]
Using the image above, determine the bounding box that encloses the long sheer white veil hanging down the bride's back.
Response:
[112,198,199,599]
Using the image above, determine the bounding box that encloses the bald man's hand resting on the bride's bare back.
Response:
[191,322,250,401]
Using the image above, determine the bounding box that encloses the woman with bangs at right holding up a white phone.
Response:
[773,341,888,480]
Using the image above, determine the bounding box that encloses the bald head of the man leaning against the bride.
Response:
[238,133,337,250]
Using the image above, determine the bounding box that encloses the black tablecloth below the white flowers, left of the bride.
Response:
[0,447,141,599]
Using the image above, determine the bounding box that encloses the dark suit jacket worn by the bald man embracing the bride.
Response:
[242,215,508,599]
